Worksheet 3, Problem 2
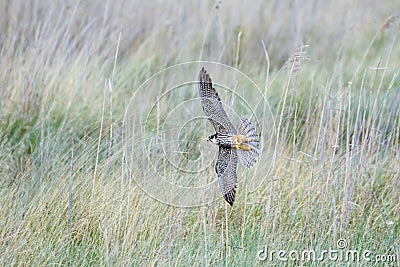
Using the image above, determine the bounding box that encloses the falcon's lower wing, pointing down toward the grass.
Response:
[215,146,238,206]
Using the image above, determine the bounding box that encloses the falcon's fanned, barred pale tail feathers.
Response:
[237,118,260,168]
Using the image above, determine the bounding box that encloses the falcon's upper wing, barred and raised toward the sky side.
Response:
[199,67,236,134]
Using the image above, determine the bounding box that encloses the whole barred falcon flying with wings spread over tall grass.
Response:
[199,67,260,206]
